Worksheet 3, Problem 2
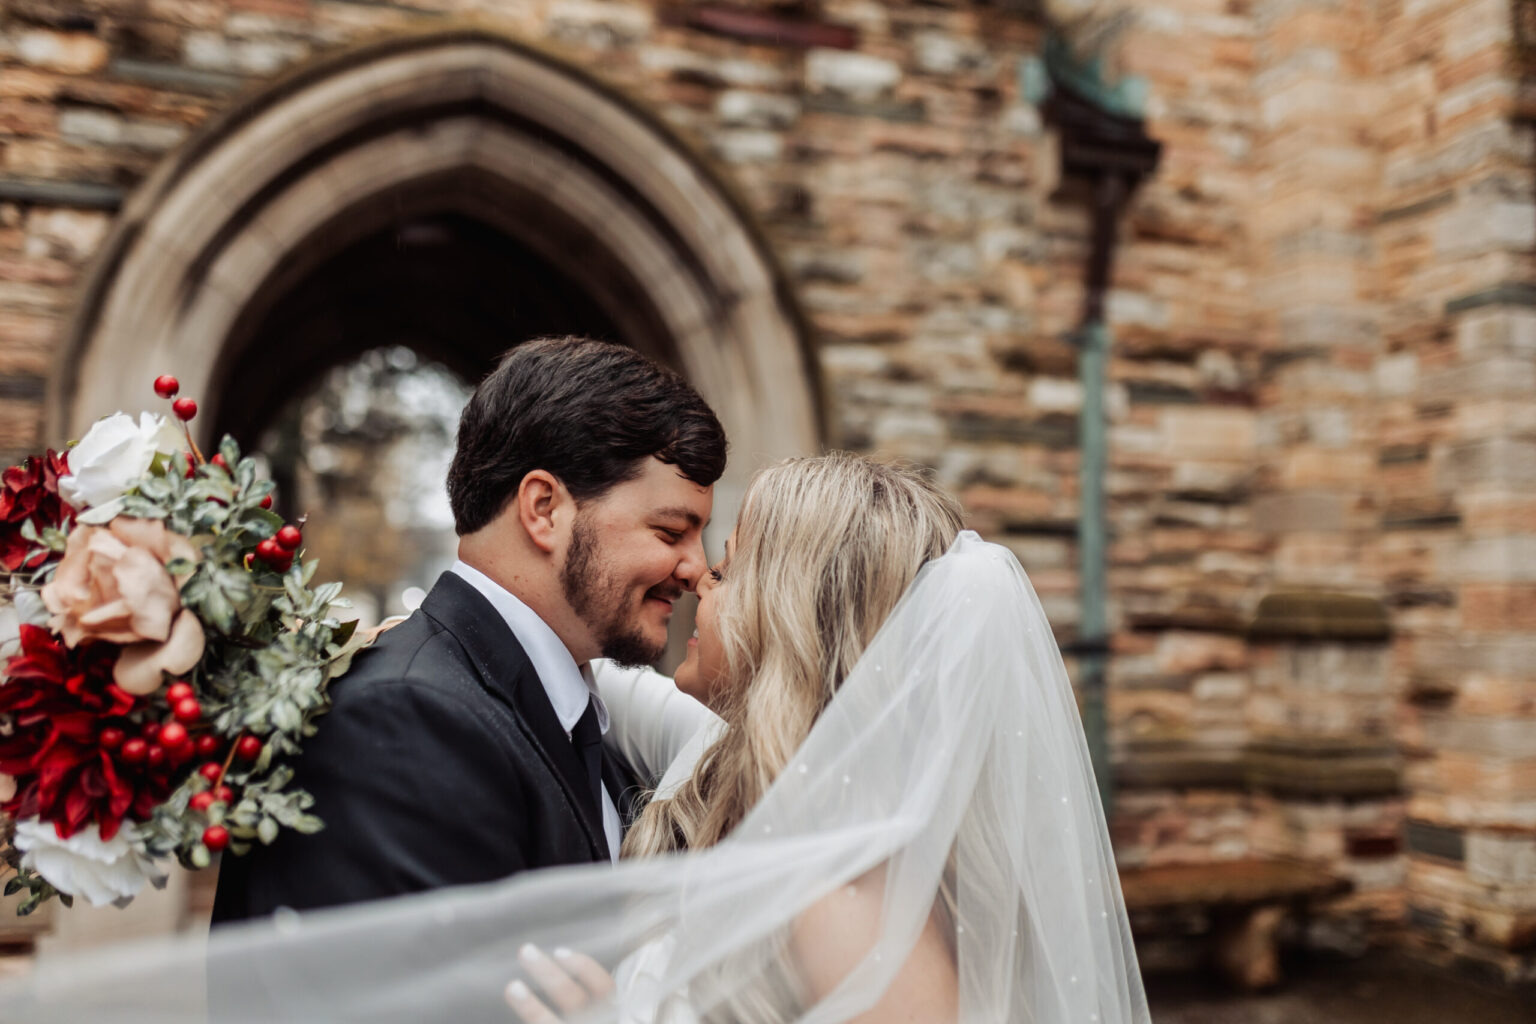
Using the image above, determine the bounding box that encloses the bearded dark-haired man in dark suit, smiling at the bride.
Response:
[214,338,725,924]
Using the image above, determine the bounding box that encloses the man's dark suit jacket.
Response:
[214,573,639,924]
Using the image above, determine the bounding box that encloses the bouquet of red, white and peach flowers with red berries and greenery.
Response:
[0,376,362,915]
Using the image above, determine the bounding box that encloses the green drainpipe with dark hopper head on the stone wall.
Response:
[1021,32,1163,815]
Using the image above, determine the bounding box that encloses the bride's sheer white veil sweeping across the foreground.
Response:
[0,533,1149,1024]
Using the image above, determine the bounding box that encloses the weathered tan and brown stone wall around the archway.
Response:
[0,0,1536,973]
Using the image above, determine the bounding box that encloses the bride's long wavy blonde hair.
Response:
[624,453,962,857]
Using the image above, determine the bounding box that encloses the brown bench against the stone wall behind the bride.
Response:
[1120,860,1353,990]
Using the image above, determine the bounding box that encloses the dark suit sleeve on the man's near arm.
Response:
[238,679,527,913]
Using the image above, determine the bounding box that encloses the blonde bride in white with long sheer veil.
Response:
[0,454,1149,1024]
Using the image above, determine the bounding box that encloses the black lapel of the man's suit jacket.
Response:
[421,573,608,860]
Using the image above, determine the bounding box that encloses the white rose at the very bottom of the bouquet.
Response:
[14,818,166,907]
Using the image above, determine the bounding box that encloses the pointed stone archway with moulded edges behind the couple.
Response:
[48,29,823,497]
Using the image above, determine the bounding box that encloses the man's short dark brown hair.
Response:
[449,338,725,536]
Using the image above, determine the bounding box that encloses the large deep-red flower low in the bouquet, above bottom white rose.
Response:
[0,625,170,840]
